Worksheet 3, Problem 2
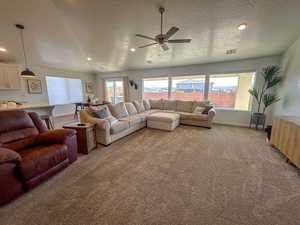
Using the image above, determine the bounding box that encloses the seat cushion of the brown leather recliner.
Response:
[19,144,68,181]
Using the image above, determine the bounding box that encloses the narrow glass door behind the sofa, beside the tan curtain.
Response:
[105,80,124,104]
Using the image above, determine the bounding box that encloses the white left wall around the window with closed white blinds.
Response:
[0,63,95,116]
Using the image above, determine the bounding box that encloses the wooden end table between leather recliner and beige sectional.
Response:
[63,123,97,154]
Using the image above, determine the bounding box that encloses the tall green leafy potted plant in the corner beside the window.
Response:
[249,65,282,128]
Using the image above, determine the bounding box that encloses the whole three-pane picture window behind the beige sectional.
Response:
[143,72,255,110]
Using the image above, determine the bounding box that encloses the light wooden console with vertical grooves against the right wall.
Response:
[271,116,300,168]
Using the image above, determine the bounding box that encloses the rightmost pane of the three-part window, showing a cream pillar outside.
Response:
[208,73,254,110]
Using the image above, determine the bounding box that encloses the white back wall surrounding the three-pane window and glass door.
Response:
[97,56,281,126]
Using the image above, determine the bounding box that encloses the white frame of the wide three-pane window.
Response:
[142,70,257,112]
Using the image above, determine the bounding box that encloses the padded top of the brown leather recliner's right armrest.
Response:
[35,129,76,145]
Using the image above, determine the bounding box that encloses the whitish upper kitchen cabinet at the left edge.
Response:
[0,64,21,90]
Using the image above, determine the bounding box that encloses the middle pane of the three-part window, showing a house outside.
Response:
[171,76,205,101]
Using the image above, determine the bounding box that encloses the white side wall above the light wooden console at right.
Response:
[275,37,300,116]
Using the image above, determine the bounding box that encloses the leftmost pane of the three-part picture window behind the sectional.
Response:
[144,77,169,99]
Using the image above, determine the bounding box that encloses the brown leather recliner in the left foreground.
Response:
[0,110,77,205]
